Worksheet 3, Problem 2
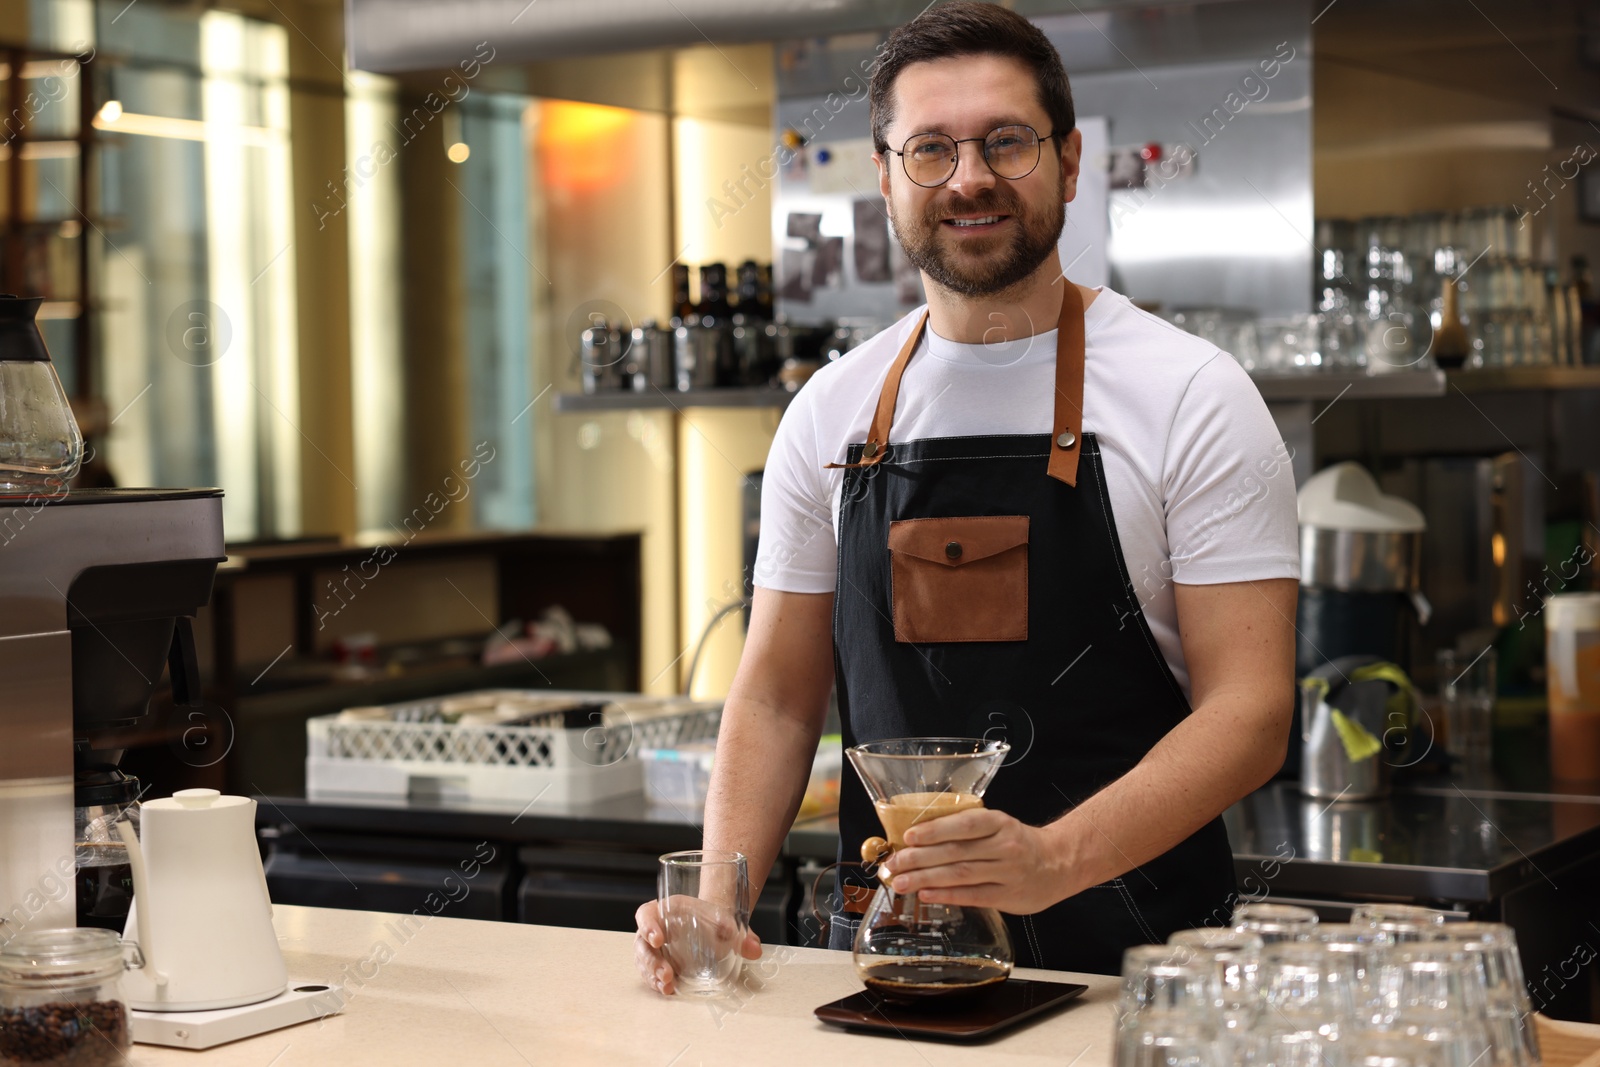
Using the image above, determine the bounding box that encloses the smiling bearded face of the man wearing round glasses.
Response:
[872,56,1082,296]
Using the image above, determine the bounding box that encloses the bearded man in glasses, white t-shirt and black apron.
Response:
[635,2,1298,992]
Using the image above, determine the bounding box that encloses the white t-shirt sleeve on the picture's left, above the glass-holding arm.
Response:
[752,387,838,593]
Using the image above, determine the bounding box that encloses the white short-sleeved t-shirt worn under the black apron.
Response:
[754,288,1299,693]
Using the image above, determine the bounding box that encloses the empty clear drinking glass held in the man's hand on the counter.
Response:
[656,849,750,997]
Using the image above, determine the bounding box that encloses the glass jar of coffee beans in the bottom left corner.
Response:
[0,928,138,1067]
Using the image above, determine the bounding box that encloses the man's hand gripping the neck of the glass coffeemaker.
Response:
[886,808,1069,915]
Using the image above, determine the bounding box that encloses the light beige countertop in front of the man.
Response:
[131,904,1118,1067]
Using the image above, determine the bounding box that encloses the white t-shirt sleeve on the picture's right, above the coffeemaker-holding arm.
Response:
[1162,352,1299,585]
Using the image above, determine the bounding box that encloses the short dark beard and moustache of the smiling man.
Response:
[890,177,1067,296]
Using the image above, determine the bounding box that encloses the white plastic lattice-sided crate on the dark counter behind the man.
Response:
[306,689,722,803]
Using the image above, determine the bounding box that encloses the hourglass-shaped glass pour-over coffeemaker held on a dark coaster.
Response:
[845,737,1013,1001]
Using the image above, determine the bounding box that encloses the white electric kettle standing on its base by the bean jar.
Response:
[117,789,288,1011]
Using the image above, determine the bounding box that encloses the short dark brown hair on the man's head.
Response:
[867,0,1077,152]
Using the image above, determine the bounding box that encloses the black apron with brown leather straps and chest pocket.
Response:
[830,280,1235,974]
